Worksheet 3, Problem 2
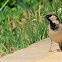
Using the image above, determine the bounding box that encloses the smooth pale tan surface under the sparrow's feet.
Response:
[0,38,62,62]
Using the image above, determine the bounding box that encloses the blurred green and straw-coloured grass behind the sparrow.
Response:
[0,0,62,56]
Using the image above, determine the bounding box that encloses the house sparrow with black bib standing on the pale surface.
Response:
[45,13,62,52]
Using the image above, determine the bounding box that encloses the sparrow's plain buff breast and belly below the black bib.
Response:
[48,24,62,43]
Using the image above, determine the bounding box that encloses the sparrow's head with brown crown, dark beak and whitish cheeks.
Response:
[45,13,60,24]
